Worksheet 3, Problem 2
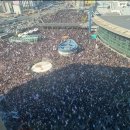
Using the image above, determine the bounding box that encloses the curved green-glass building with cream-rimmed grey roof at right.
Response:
[93,16,130,58]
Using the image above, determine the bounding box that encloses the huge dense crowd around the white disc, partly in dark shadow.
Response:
[0,8,130,130]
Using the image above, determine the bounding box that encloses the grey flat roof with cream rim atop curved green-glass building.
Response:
[93,16,130,38]
